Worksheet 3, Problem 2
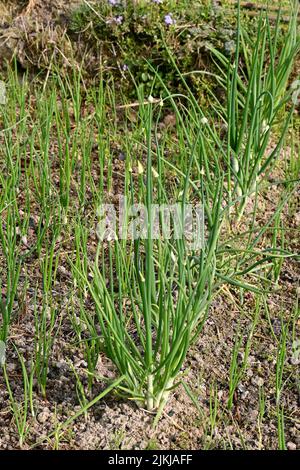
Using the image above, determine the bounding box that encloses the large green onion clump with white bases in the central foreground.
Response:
[80,104,223,417]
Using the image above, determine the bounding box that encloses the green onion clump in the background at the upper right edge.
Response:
[207,1,300,218]
